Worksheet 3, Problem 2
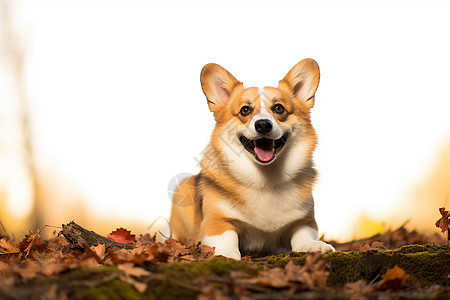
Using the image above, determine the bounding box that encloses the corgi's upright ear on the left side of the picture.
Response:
[200,64,242,112]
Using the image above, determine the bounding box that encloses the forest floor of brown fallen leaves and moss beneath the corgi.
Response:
[0,222,450,300]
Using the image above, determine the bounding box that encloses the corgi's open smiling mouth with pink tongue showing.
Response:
[239,133,288,164]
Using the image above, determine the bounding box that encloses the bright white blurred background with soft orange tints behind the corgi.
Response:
[0,0,450,241]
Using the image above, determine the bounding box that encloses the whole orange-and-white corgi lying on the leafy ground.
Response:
[170,59,334,260]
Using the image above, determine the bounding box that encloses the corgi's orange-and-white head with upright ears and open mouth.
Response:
[200,59,320,184]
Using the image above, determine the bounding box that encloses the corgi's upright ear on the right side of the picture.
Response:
[280,58,320,108]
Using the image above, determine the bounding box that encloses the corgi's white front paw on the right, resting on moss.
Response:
[291,225,335,253]
